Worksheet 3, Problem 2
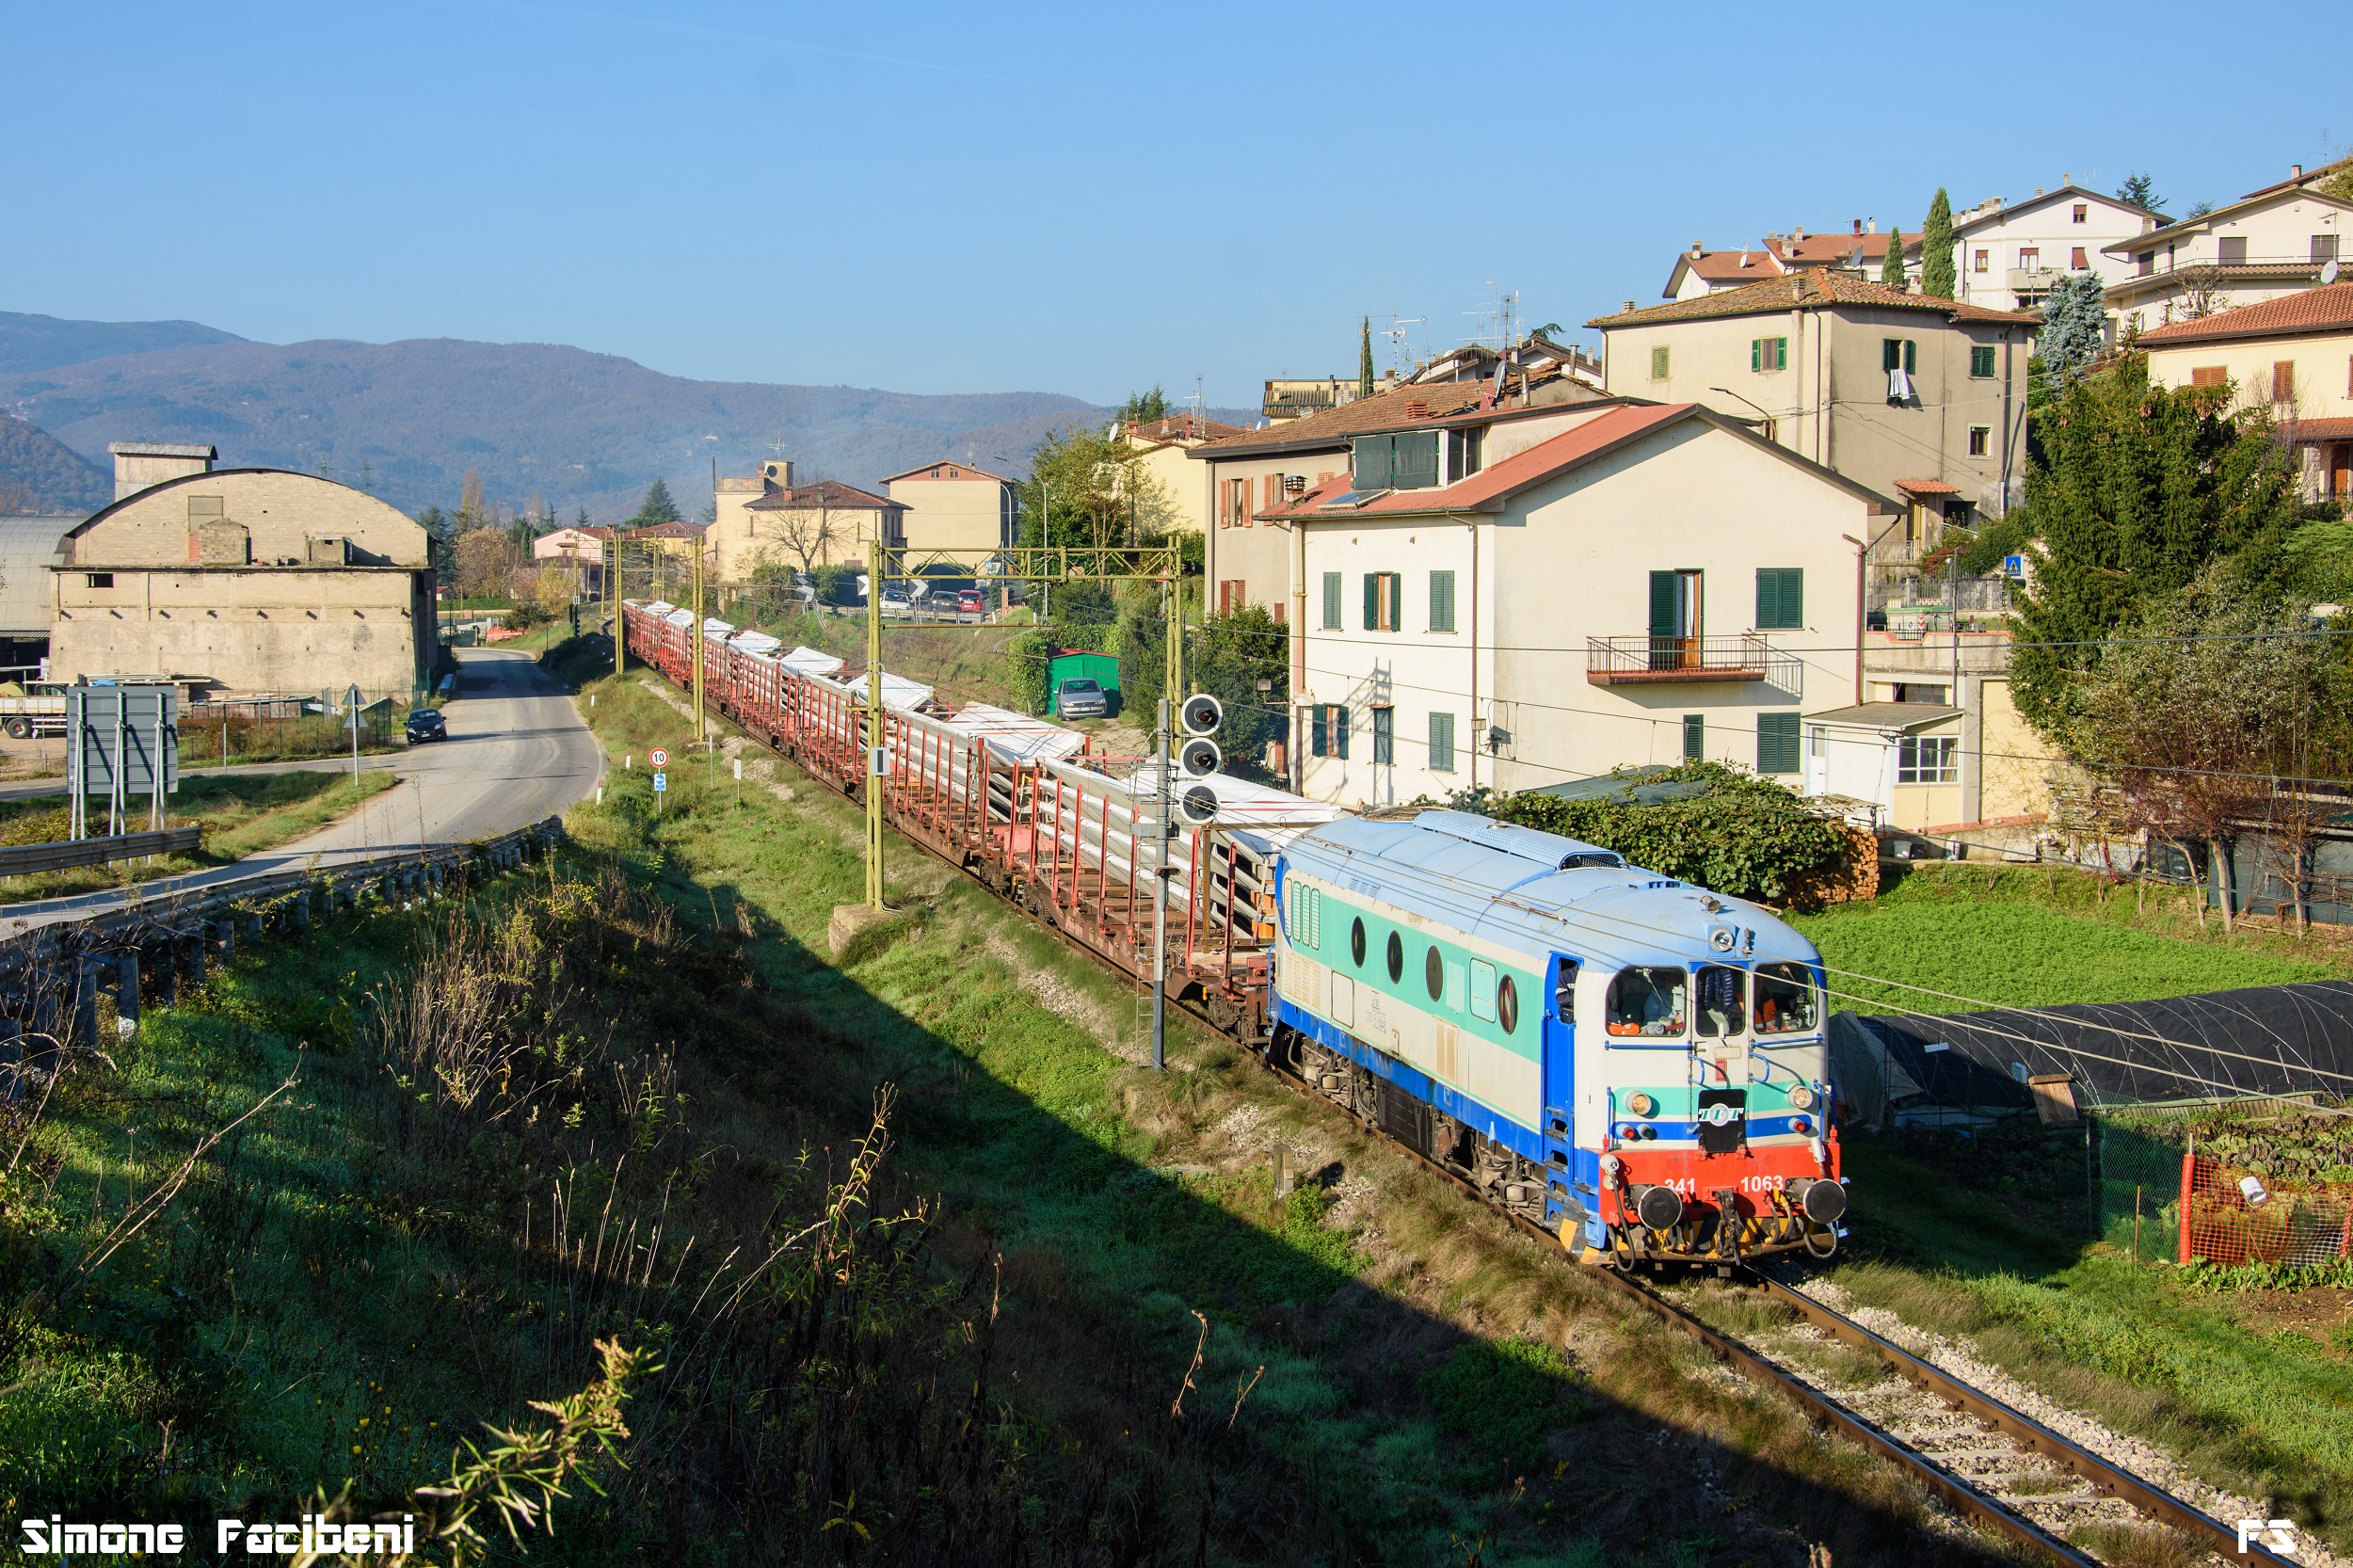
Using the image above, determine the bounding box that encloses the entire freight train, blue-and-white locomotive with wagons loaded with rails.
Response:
[621,600,1848,1267]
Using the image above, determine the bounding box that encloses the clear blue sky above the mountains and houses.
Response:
[0,0,2353,405]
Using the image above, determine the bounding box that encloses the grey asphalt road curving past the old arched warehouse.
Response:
[0,648,605,933]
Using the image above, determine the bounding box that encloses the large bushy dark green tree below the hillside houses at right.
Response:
[2012,353,2301,746]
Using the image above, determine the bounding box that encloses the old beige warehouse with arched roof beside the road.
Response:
[50,442,436,696]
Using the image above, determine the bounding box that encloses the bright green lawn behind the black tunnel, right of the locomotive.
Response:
[1791,867,2346,1013]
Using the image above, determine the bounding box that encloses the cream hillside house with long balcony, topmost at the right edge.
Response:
[2108,158,2353,337]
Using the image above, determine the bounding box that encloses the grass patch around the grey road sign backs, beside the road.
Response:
[0,767,398,904]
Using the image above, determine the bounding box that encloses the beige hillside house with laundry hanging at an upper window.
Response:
[1589,266,2038,543]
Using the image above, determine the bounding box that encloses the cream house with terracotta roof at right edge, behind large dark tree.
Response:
[2135,280,2353,504]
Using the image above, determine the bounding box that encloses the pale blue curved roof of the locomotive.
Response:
[1283,810,1821,968]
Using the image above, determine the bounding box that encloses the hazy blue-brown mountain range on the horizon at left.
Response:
[0,313,1255,522]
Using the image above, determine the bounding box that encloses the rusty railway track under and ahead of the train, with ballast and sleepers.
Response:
[654,659,2313,1568]
